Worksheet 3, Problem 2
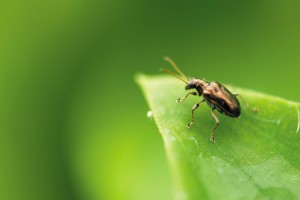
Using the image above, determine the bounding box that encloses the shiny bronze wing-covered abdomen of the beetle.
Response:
[203,82,241,117]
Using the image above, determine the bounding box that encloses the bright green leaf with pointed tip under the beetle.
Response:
[136,75,300,200]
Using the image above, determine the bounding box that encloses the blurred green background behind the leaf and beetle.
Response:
[0,0,300,200]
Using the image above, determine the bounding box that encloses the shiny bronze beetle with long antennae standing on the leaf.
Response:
[161,57,256,143]
